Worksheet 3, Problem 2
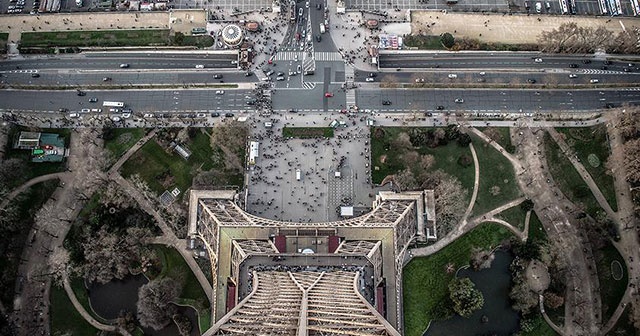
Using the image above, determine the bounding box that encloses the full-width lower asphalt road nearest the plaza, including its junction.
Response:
[0,83,640,113]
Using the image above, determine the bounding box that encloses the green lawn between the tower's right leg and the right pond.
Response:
[403,223,512,336]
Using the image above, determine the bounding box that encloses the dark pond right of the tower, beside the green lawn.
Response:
[424,250,520,336]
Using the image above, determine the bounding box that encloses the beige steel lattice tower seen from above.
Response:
[189,190,433,335]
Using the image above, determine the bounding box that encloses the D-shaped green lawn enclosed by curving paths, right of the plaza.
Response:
[471,136,522,215]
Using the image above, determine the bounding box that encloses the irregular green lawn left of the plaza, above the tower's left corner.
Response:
[121,132,214,196]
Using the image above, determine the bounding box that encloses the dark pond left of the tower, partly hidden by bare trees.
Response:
[88,275,200,336]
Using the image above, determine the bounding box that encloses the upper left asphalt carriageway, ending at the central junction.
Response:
[0,53,237,71]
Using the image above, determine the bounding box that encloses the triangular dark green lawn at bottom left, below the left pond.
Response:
[50,286,98,336]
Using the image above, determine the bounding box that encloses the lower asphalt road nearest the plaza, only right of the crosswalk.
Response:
[356,88,640,113]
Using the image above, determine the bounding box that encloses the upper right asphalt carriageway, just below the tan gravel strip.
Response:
[379,51,640,71]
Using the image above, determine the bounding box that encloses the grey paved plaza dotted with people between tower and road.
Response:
[247,114,374,222]
